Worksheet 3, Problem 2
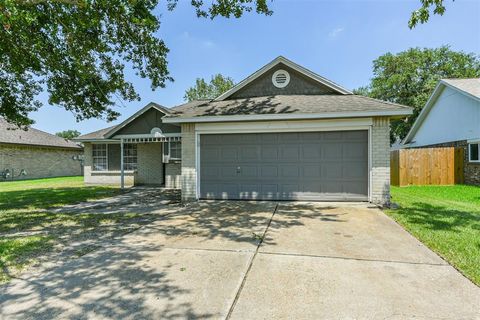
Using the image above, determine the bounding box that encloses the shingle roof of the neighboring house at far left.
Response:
[0,118,82,149]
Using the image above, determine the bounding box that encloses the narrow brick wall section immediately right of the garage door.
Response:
[370,117,390,205]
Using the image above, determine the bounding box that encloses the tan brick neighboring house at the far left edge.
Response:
[0,118,83,181]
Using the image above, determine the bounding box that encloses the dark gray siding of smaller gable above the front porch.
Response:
[115,108,180,136]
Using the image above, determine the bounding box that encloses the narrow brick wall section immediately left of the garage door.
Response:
[181,123,197,201]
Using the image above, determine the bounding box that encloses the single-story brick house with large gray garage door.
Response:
[78,57,412,203]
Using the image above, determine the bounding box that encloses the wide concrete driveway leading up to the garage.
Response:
[0,202,480,319]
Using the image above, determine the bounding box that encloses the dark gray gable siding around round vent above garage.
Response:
[227,63,338,100]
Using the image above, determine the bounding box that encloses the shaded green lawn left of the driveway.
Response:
[0,177,125,282]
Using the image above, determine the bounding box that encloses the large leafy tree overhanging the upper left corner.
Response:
[0,0,272,127]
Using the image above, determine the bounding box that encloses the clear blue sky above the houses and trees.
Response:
[30,0,480,134]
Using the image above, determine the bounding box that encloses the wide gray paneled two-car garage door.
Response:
[200,130,368,201]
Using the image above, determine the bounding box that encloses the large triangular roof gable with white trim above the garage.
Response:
[215,56,351,101]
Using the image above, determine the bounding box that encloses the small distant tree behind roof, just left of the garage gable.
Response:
[183,74,234,102]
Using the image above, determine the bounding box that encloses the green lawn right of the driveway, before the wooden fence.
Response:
[386,185,480,285]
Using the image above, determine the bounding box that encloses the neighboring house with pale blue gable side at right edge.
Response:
[403,79,480,185]
